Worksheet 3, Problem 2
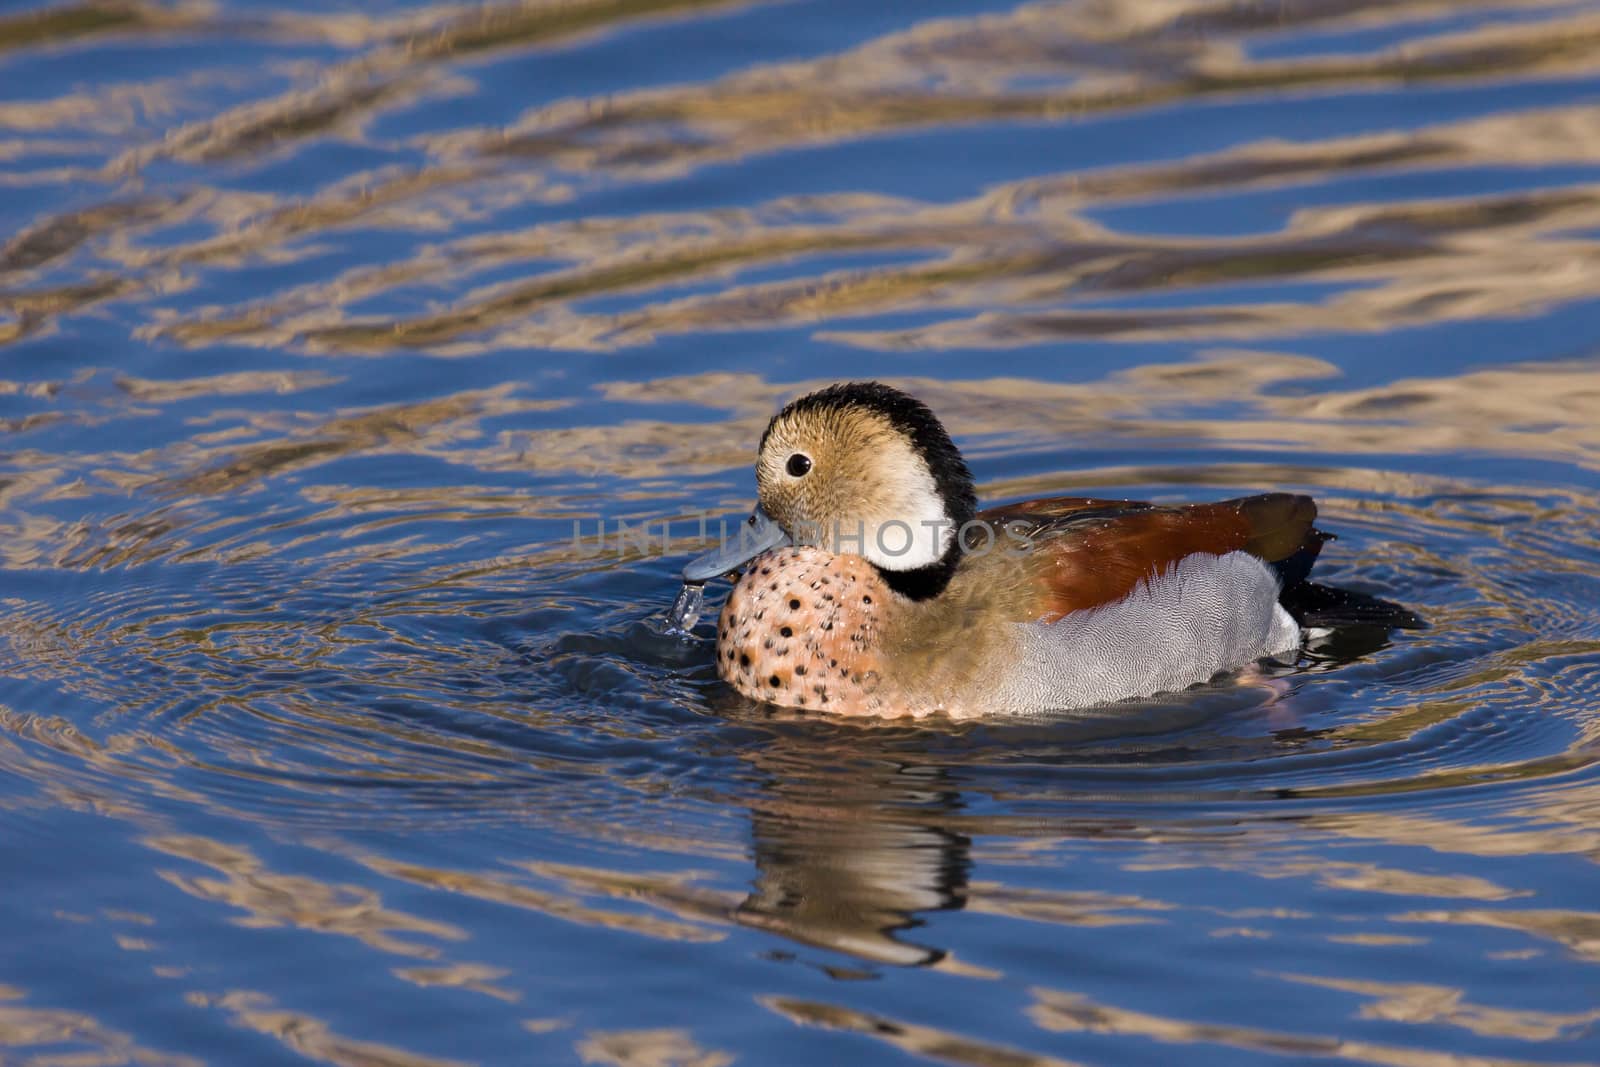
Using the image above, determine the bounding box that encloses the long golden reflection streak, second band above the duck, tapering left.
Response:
[140,167,1600,355]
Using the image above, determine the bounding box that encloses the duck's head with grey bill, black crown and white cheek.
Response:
[683,382,978,598]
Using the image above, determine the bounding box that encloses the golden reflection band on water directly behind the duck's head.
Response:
[483,350,1600,493]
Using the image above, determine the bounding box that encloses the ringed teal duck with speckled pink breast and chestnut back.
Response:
[683,382,1328,718]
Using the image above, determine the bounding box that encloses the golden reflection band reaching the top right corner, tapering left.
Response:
[485,2,1600,184]
